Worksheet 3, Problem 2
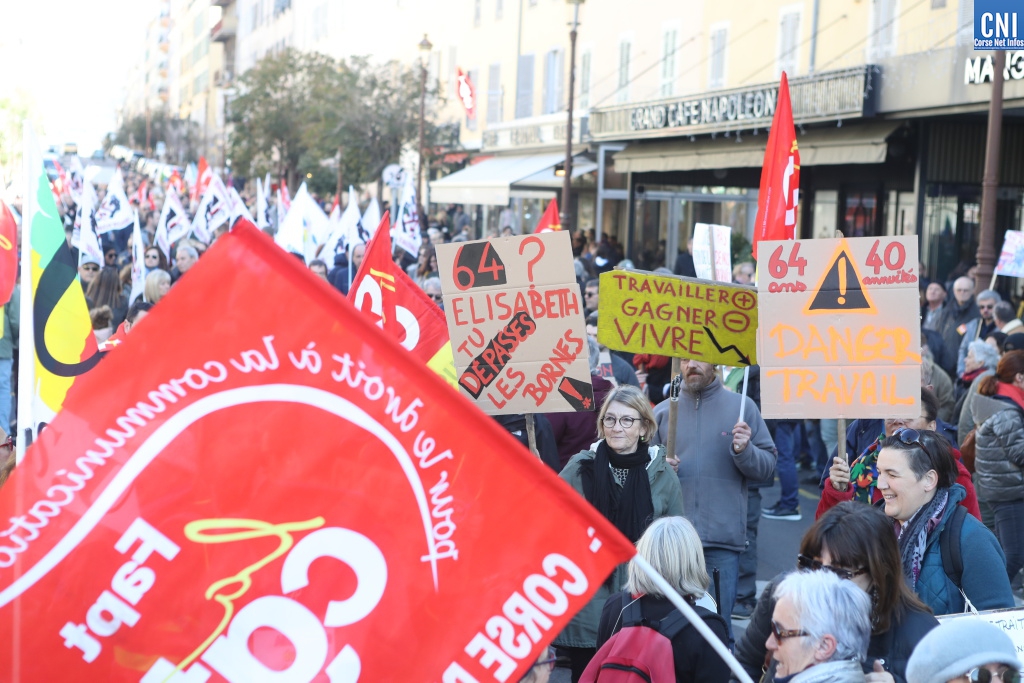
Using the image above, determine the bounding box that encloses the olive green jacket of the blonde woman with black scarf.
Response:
[555,445,683,647]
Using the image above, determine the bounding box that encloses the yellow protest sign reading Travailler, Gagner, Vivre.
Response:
[597,270,758,366]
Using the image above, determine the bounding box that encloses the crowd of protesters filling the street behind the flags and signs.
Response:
[0,154,1024,683]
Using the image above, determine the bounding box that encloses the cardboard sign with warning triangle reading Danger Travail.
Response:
[758,236,921,419]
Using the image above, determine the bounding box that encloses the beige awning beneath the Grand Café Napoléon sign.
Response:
[614,122,902,173]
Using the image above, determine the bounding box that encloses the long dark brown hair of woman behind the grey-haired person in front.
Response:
[800,501,931,634]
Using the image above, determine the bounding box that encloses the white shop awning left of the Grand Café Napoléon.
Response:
[430,154,575,206]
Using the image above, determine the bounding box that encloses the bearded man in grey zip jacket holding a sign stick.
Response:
[653,358,776,638]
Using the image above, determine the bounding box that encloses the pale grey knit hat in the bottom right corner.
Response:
[906,616,1021,683]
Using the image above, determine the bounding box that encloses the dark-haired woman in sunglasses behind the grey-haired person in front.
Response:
[736,501,938,683]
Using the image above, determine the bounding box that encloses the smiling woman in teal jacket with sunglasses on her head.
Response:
[878,429,1014,614]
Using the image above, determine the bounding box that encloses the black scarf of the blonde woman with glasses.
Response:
[581,440,654,543]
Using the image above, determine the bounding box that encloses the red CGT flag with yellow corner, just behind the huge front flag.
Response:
[348,211,458,387]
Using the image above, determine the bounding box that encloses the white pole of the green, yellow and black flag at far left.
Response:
[14,123,40,465]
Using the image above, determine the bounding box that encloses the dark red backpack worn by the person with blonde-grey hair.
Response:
[580,593,689,683]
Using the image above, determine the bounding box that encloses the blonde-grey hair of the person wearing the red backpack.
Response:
[626,517,710,599]
